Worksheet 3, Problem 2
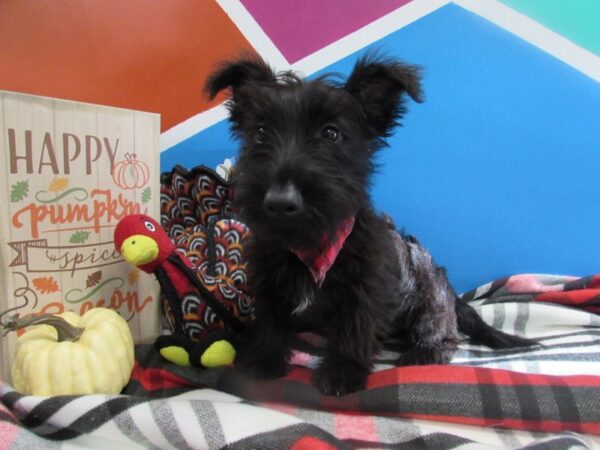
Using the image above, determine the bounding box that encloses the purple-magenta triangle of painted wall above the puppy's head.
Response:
[241,0,410,63]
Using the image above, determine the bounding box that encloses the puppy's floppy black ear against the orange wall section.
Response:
[205,57,277,100]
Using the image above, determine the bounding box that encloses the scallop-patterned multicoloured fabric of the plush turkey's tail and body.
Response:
[160,166,252,342]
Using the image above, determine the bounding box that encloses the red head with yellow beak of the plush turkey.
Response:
[114,214,175,273]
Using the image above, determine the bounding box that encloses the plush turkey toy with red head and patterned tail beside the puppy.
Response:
[114,166,252,367]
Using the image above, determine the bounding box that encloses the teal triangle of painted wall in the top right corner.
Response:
[501,0,600,55]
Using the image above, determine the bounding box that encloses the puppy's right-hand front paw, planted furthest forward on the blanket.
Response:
[313,362,369,397]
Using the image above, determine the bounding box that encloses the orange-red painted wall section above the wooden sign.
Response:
[0,0,251,131]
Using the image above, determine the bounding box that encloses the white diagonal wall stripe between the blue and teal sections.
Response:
[454,0,600,82]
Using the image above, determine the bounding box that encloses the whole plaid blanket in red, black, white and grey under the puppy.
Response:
[0,275,600,450]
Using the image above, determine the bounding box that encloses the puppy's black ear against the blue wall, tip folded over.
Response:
[344,56,423,137]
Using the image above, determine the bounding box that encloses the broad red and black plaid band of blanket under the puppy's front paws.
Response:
[128,349,600,435]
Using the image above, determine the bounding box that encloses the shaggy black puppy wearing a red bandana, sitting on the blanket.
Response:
[206,57,532,395]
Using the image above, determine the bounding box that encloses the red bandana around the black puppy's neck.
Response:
[291,217,354,286]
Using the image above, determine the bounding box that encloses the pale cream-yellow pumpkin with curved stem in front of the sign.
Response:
[3,308,134,396]
